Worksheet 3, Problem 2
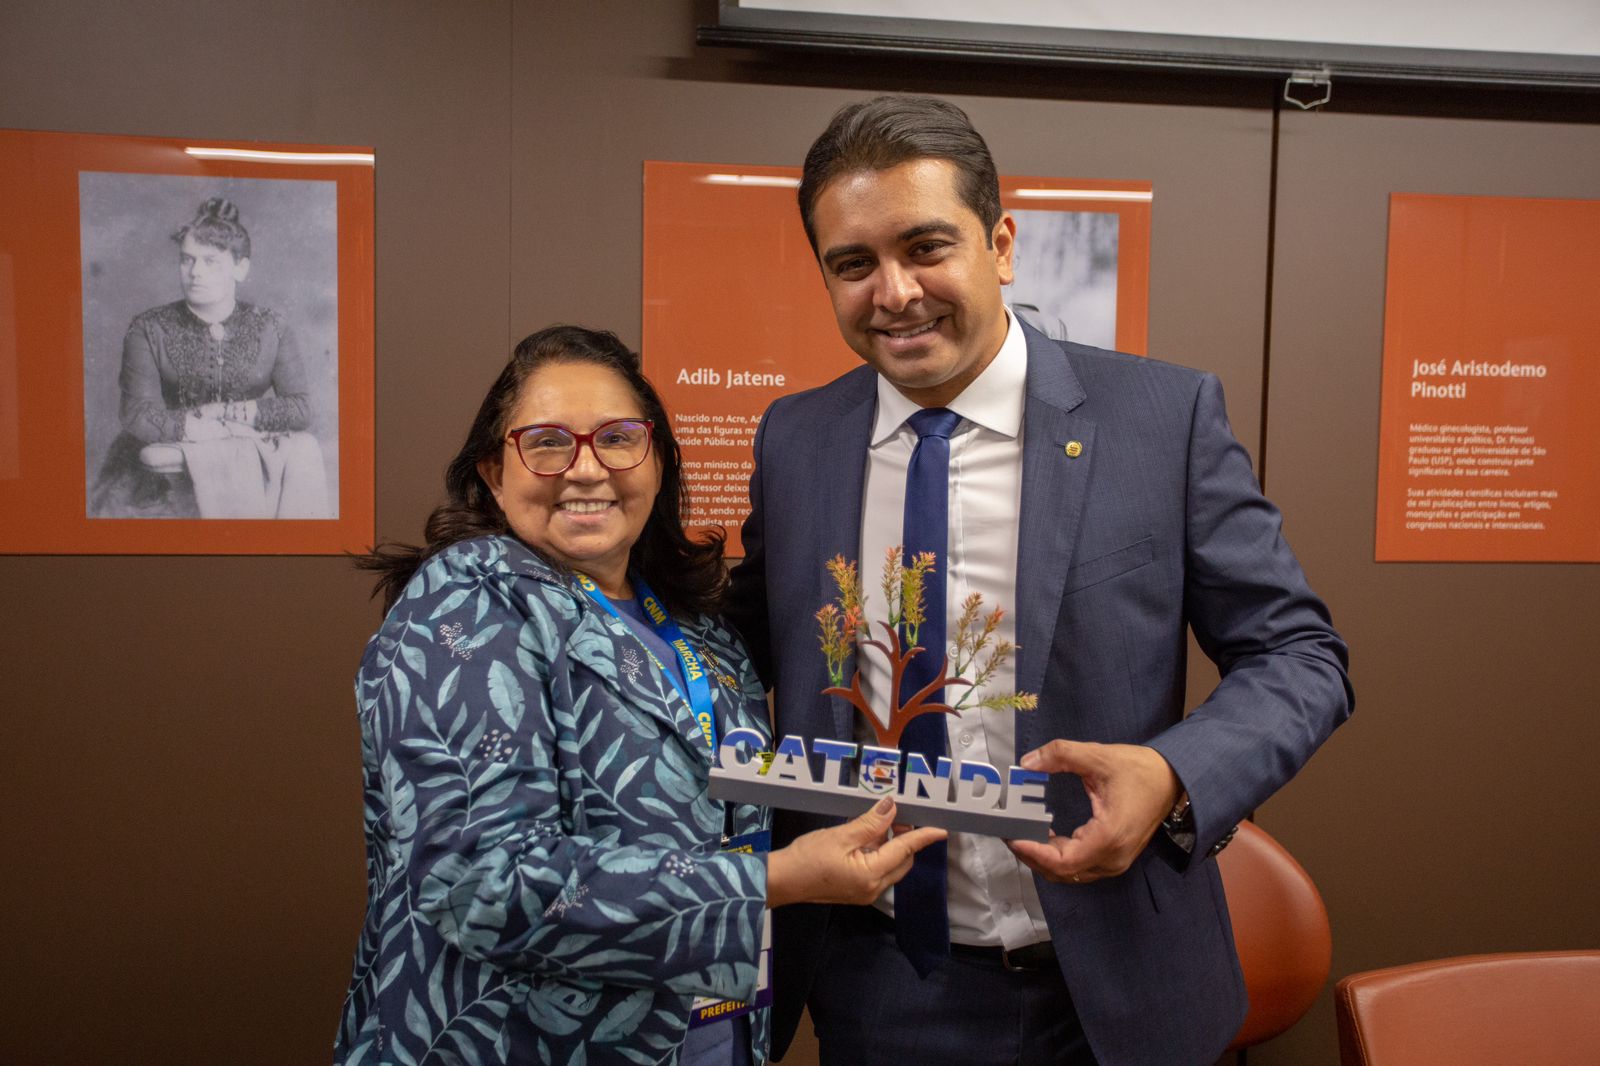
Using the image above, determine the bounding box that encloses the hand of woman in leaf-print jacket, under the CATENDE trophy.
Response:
[766,795,949,908]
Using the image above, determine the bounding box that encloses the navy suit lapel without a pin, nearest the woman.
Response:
[812,367,878,739]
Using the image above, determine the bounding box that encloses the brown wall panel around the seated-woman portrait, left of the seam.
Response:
[0,0,510,1066]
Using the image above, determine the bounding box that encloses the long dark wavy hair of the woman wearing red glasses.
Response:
[355,325,728,615]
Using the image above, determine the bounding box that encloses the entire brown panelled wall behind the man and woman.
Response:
[0,0,1600,1066]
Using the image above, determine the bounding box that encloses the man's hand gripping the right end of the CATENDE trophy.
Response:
[1006,739,1182,885]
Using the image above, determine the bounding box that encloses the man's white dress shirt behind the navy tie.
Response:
[856,309,1050,948]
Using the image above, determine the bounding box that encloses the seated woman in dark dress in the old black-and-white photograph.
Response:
[88,197,333,519]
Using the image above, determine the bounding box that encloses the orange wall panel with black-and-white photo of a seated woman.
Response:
[0,130,374,555]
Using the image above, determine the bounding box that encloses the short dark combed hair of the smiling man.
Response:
[800,96,1000,253]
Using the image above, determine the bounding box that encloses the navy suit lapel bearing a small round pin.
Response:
[1016,323,1094,754]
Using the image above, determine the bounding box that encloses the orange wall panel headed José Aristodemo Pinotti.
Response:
[1373,192,1600,563]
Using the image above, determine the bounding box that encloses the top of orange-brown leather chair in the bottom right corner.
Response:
[1334,951,1600,1066]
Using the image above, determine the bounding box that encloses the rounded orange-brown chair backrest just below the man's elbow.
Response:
[1216,821,1333,1050]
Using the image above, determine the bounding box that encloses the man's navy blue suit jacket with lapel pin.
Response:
[730,323,1352,1066]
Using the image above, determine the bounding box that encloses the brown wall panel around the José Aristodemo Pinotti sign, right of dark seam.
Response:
[1251,93,1600,1063]
